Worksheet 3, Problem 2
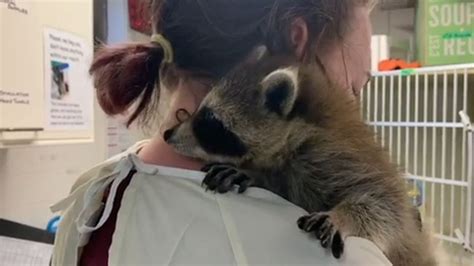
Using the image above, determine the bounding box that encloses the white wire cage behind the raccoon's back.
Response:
[360,64,474,250]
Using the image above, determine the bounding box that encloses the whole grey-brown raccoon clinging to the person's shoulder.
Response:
[164,51,436,265]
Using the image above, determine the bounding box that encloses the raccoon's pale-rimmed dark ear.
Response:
[262,67,298,116]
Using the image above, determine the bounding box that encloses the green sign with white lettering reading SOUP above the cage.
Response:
[417,0,474,66]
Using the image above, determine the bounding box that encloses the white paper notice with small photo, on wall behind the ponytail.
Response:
[44,29,94,130]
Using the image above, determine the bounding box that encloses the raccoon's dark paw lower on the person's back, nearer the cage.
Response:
[298,212,344,259]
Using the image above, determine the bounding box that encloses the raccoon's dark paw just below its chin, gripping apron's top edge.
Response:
[201,163,254,193]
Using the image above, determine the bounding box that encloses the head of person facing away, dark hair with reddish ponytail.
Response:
[91,0,374,132]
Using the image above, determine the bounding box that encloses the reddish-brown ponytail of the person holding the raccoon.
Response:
[89,43,164,126]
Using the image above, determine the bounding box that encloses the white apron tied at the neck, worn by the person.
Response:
[52,142,390,266]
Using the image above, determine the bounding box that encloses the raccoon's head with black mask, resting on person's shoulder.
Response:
[164,58,298,165]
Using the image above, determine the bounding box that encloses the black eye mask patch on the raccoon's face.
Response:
[192,107,247,157]
